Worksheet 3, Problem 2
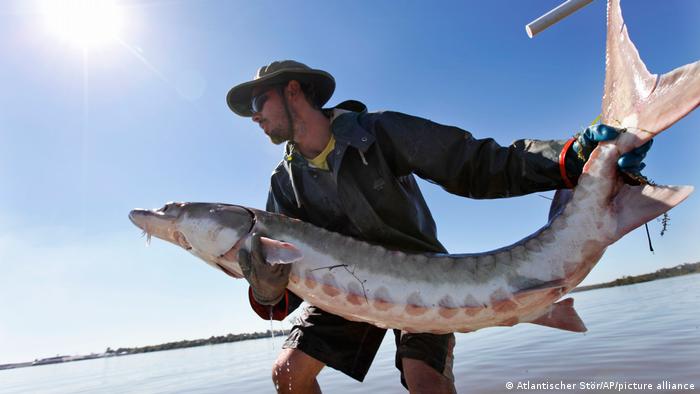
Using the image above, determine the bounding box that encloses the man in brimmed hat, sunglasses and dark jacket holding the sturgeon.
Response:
[227,60,648,393]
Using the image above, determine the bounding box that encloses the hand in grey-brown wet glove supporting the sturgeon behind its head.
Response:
[238,233,292,305]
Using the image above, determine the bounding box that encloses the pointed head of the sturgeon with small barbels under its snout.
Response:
[129,202,255,277]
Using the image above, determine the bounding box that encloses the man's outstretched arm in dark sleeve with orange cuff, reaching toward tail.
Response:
[371,112,580,198]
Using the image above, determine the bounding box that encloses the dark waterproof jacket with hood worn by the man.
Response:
[250,102,580,320]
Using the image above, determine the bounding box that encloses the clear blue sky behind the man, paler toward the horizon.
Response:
[0,0,700,363]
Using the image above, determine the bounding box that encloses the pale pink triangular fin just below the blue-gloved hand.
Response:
[611,185,694,240]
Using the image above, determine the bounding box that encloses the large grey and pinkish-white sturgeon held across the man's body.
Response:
[129,0,700,333]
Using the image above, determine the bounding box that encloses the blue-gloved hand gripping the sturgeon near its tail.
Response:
[573,124,653,181]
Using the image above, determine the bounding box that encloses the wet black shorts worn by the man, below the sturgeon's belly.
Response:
[282,306,455,387]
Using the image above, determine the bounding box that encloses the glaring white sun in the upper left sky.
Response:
[41,0,124,48]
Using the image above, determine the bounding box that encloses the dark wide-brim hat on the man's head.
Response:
[226,60,335,117]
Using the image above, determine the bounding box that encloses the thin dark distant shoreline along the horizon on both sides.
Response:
[0,262,700,370]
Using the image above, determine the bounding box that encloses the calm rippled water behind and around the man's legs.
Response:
[0,275,700,394]
